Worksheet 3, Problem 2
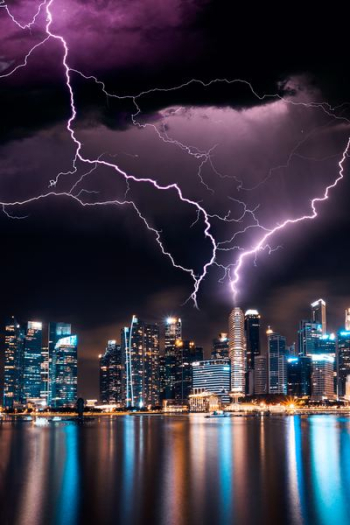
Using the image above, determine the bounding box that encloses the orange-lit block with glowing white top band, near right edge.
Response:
[311,355,334,401]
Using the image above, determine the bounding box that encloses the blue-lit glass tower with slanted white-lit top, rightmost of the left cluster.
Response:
[50,335,78,407]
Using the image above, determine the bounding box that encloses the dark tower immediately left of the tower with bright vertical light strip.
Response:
[99,339,124,405]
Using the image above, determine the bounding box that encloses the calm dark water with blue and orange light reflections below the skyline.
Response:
[0,414,350,525]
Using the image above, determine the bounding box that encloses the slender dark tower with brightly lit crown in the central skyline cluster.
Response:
[164,317,182,399]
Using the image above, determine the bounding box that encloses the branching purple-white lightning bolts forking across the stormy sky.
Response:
[0,0,350,307]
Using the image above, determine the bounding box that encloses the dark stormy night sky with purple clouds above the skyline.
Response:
[0,0,350,397]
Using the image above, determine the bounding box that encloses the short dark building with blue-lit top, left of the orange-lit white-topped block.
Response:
[287,356,312,397]
